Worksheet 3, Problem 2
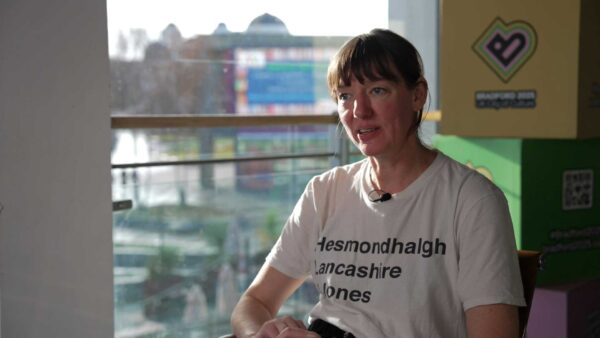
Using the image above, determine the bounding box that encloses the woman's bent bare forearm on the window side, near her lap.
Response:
[231,264,304,338]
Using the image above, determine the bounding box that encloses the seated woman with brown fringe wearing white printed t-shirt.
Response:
[232,29,525,338]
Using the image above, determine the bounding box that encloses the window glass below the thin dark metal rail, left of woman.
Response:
[113,158,331,337]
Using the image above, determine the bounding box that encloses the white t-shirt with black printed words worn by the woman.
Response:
[267,153,525,338]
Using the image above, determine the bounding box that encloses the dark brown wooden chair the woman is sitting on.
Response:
[219,250,542,338]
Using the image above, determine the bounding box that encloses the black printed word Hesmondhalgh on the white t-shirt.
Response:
[317,237,446,258]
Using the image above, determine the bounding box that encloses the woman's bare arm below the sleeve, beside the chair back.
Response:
[466,304,519,338]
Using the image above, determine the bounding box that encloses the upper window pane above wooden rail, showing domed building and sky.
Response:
[108,0,387,115]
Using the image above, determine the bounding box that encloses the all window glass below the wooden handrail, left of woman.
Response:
[112,125,339,337]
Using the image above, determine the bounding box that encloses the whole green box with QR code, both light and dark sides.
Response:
[434,136,600,285]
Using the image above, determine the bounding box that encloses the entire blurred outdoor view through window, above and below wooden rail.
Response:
[108,0,436,338]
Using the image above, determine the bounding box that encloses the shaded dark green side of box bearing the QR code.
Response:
[521,139,600,284]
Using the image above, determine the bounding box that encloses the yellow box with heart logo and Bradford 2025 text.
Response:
[440,0,600,139]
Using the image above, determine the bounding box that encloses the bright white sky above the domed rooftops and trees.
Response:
[107,0,388,53]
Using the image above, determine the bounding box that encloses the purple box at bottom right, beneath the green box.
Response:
[527,280,600,338]
